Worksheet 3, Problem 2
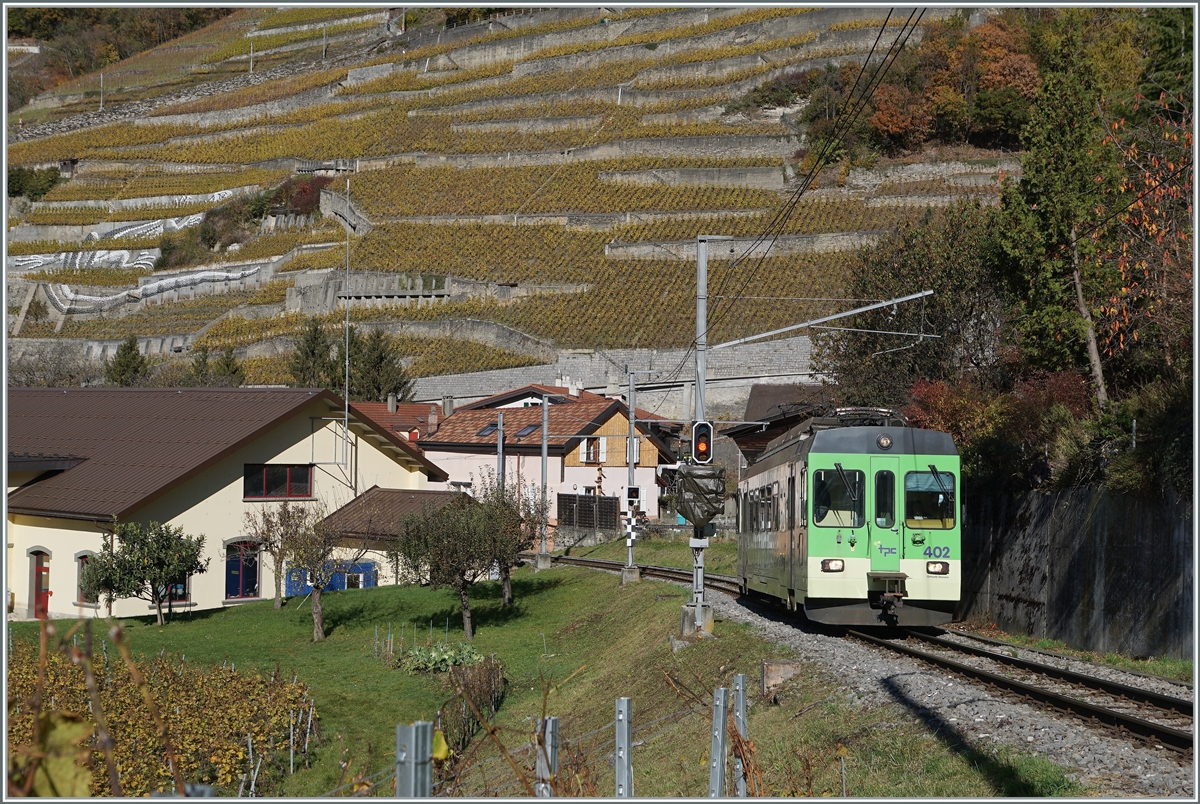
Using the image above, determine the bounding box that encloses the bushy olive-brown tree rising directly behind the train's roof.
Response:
[814,203,1003,407]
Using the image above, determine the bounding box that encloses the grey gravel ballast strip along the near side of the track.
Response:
[706,592,1195,798]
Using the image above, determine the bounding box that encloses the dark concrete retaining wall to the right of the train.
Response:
[959,488,1195,659]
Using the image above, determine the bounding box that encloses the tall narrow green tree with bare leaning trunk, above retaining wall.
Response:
[1000,23,1117,410]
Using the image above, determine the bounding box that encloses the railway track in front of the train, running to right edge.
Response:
[848,630,1194,755]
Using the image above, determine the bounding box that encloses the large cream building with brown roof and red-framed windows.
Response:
[6,388,446,618]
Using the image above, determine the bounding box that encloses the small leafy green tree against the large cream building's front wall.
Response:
[80,522,209,625]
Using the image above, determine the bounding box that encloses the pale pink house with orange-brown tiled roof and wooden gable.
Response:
[369,385,676,535]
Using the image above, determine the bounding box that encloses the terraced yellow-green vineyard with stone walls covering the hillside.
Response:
[7,7,1012,383]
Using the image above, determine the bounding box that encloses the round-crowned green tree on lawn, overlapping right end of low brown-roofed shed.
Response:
[396,494,484,640]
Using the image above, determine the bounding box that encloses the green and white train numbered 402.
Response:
[738,408,962,625]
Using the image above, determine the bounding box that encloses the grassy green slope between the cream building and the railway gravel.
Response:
[7,568,1080,796]
